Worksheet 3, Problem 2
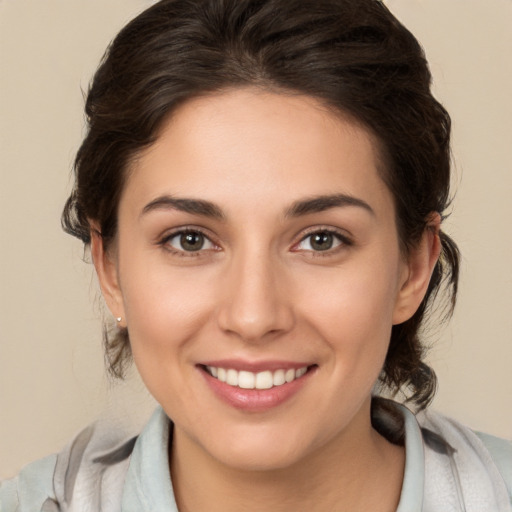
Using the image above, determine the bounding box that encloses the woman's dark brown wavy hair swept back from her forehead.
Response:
[62,0,459,407]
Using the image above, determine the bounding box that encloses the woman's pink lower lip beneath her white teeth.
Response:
[199,368,313,412]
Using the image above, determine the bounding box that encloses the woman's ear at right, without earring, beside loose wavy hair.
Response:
[393,212,441,325]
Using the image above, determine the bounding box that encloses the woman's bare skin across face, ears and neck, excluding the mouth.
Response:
[92,89,439,512]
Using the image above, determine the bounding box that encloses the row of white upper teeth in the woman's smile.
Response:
[206,366,308,389]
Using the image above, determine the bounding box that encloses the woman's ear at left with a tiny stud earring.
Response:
[90,222,126,327]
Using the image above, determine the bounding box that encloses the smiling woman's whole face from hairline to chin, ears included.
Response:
[93,89,429,469]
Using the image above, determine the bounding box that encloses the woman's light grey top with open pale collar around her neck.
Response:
[0,398,512,512]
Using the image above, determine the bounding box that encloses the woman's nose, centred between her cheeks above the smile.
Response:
[218,246,295,343]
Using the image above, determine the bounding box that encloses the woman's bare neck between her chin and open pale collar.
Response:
[170,405,405,512]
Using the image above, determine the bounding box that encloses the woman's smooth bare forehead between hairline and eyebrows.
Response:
[126,88,389,220]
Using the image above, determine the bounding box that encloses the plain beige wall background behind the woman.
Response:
[0,0,512,477]
